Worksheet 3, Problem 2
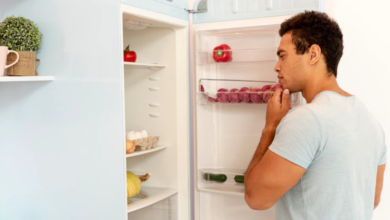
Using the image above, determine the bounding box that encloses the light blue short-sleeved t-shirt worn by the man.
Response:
[269,91,387,220]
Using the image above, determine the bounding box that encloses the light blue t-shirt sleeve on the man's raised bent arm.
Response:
[269,107,323,169]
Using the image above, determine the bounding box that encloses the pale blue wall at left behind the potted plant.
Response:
[0,0,126,220]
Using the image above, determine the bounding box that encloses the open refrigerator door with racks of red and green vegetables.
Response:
[192,16,304,220]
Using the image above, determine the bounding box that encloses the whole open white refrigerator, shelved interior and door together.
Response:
[121,1,318,220]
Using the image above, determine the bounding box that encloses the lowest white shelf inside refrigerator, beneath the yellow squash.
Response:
[127,186,177,213]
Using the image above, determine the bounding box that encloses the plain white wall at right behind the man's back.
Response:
[333,0,390,220]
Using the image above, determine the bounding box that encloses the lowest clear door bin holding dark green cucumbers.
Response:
[198,169,245,196]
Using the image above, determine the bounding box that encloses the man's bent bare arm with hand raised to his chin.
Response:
[244,90,306,210]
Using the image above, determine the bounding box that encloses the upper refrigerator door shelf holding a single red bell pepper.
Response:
[197,47,278,65]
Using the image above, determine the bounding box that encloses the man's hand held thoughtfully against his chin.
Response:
[265,89,291,129]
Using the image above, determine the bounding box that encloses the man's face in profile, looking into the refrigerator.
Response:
[274,32,307,93]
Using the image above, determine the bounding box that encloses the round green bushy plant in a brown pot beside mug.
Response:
[0,16,42,76]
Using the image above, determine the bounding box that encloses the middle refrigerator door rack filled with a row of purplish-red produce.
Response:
[197,79,302,106]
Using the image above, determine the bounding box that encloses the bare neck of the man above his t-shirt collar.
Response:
[302,74,351,103]
